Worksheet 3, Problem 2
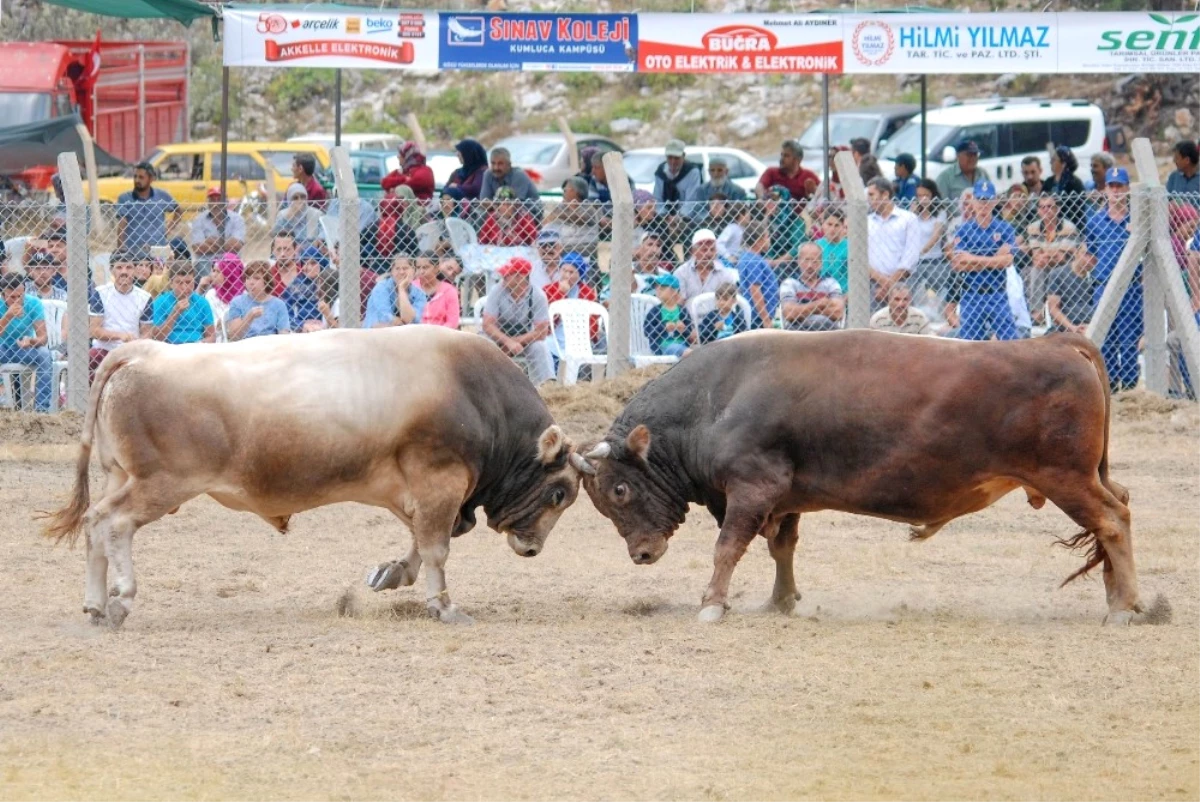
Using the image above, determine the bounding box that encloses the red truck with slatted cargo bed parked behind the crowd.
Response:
[0,40,191,188]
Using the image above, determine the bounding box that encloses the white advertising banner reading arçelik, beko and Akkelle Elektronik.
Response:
[224,6,438,71]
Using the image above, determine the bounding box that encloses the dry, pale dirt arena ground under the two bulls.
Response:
[0,383,1200,801]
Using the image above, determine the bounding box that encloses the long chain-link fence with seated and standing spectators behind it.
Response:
[9,144,1200,417]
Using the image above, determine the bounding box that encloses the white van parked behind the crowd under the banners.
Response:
[880,98,1109,190]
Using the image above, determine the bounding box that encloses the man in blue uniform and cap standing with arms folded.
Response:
[950,181,1018,340]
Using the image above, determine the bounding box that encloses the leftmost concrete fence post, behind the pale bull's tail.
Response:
[54,152,91,412]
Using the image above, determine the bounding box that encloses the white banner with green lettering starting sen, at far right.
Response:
[1058,12,1200,73]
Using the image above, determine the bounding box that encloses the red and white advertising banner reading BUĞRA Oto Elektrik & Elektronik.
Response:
[636,14,842,73]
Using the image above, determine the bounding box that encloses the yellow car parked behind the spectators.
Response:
[83,142,330,209]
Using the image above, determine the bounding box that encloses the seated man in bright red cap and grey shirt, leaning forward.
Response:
[482,257,554,385]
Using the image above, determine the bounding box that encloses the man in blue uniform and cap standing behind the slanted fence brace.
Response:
[1080,167,1144,393]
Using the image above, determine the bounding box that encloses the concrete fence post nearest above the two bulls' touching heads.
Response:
[604,152,634,378]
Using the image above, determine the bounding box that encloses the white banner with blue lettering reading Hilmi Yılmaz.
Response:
[842,13,1058,74]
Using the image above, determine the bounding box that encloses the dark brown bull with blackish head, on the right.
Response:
[584,331,1142,622]
